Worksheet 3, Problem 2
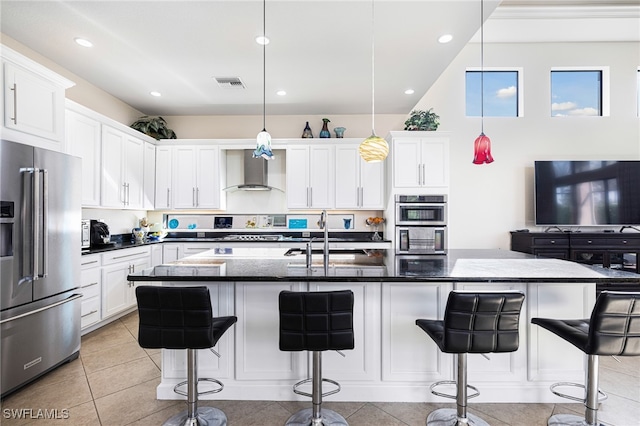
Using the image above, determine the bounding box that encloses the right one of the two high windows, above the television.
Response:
[551,69,608,117]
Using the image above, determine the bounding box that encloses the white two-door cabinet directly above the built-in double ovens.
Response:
[390,131,449,188]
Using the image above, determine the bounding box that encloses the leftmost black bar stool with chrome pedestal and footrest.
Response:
[136,286,238,426]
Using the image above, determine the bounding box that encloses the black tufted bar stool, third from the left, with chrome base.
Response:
[416,291,524,426]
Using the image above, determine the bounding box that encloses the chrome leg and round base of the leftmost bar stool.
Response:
[163,349,227,426]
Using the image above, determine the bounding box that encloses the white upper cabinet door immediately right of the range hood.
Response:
[286,146,310,209]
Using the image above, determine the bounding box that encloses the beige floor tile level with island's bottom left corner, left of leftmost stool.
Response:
[87,357,160,399]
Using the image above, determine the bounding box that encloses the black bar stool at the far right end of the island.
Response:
[531,291,640,426]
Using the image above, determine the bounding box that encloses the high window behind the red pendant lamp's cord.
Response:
[466,68,522,117]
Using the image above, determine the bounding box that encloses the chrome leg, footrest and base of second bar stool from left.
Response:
[285,351,349,426]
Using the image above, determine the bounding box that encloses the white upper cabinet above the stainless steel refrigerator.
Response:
[0,46,74,151]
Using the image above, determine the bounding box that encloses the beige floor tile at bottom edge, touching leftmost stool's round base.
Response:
[95,379,176,426]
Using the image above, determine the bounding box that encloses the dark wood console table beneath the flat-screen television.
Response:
[511,231,640,274]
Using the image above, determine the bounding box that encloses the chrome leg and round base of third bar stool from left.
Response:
[427,353,489,426]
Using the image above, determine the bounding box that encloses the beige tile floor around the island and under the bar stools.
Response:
[0,313,640,426]
